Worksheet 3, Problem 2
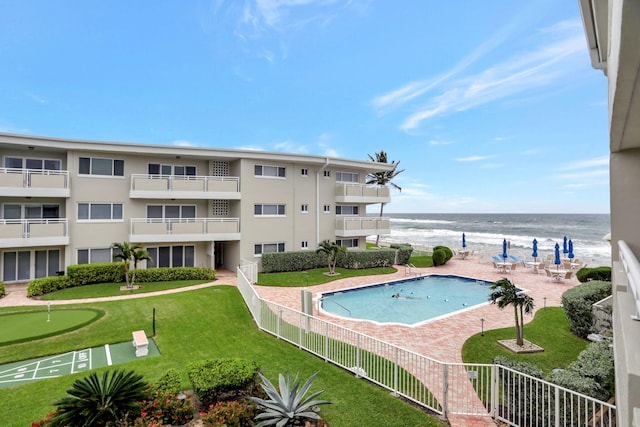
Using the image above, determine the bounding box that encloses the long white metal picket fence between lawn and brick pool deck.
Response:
[238,265,615,427]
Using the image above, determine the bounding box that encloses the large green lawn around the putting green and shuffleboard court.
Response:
[0,286,444,427]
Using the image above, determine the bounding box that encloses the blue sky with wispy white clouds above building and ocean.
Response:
[0,0,609,213]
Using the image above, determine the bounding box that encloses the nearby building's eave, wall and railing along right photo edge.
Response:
[580,0,640,427]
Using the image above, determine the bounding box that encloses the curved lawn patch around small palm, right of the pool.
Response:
[462,307,589,373]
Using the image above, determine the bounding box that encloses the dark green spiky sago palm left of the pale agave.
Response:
[48,370,147,427]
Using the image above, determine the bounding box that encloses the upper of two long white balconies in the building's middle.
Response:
[129,174,240,200]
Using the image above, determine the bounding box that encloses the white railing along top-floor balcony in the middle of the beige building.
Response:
[131,174,240,192]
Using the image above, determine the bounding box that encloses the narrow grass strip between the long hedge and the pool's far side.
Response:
[257,267,398,287]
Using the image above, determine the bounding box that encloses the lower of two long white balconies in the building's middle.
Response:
[129,218,240,243]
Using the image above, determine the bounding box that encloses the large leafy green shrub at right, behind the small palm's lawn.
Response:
[562,281,611,338]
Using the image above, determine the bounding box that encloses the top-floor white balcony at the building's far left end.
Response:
[0,168,71,197]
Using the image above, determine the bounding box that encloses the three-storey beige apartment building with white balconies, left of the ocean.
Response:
[0,133,392,283]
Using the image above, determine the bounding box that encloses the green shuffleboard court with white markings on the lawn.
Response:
[0,338,160,388]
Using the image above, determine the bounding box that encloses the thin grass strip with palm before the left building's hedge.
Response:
[42,280,208,301]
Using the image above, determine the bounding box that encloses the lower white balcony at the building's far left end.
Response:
[0,218,69,248]
